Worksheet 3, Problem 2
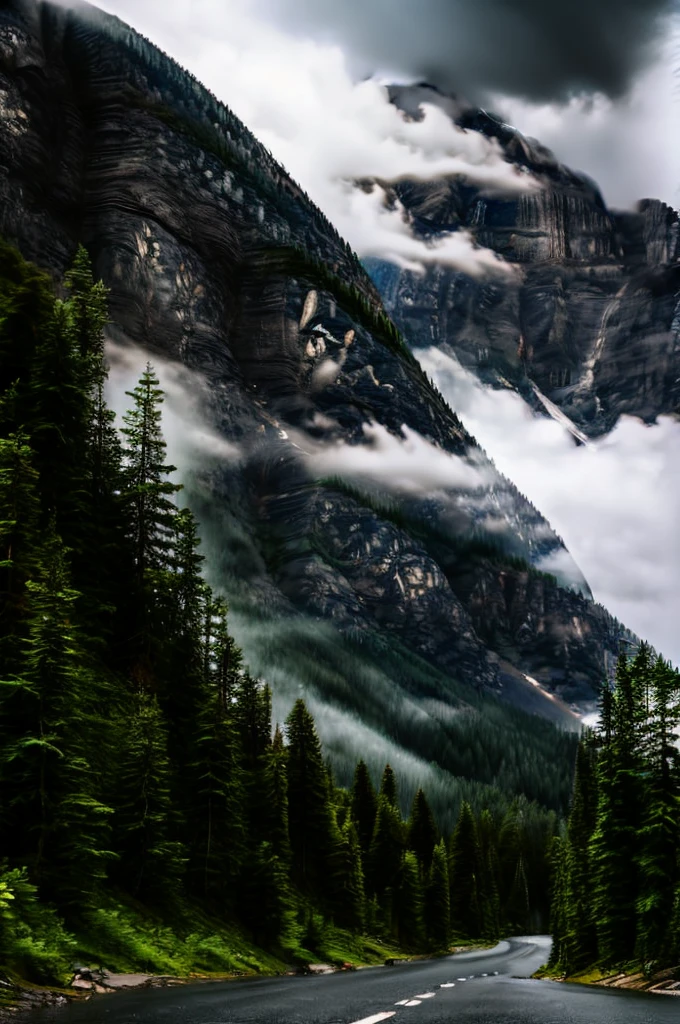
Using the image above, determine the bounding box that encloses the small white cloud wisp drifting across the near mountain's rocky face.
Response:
[300,423,490,496]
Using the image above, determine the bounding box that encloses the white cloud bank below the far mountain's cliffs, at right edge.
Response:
[419,348,680,664]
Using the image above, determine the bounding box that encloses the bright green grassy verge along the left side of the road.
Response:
[0,898,450,1020]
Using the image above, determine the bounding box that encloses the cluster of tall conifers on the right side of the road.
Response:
[552,644,680,974]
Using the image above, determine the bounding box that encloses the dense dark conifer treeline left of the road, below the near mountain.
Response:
[0,245,556,979]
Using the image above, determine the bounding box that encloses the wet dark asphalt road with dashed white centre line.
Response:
[30,936,680,1024]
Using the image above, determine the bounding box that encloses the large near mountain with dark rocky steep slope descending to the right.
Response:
[0,0,623,805]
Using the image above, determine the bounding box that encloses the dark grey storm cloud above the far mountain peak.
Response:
[257,0,677,100]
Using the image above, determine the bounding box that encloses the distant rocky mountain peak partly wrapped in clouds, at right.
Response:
[371,85,680,437]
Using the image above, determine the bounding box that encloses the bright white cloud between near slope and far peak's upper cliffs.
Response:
[95,0,524,273]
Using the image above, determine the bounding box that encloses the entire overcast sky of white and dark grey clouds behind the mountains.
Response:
[100,0,680,660]
